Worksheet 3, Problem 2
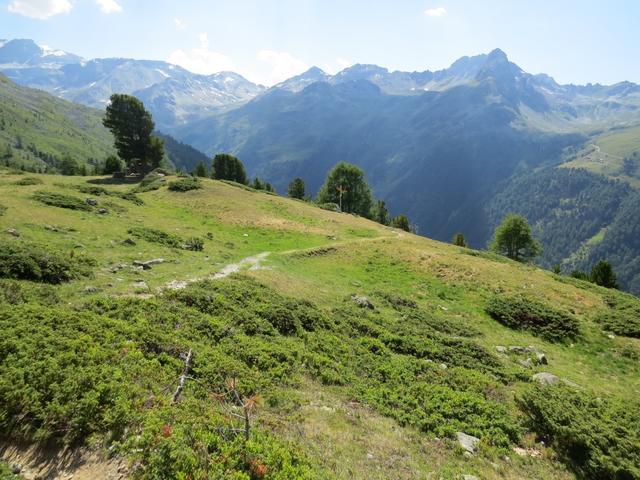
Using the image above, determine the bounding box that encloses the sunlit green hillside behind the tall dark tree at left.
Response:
[0,74,113,170]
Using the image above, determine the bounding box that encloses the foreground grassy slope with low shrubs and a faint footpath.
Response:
[0,171,640,479]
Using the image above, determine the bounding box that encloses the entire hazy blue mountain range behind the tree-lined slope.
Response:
[0,40,640,293]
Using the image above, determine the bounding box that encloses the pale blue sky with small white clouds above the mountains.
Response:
[0,0,640,85]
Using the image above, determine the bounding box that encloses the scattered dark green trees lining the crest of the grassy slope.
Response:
[103,94,618,288]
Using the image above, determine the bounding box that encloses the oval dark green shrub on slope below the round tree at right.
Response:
[486,295,579,342]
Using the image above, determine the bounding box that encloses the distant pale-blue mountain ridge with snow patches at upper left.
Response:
[0,39,264,131]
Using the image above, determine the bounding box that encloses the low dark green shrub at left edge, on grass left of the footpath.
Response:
[0,241,95,283]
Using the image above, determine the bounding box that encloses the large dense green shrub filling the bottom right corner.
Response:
[519,385,640,480]
